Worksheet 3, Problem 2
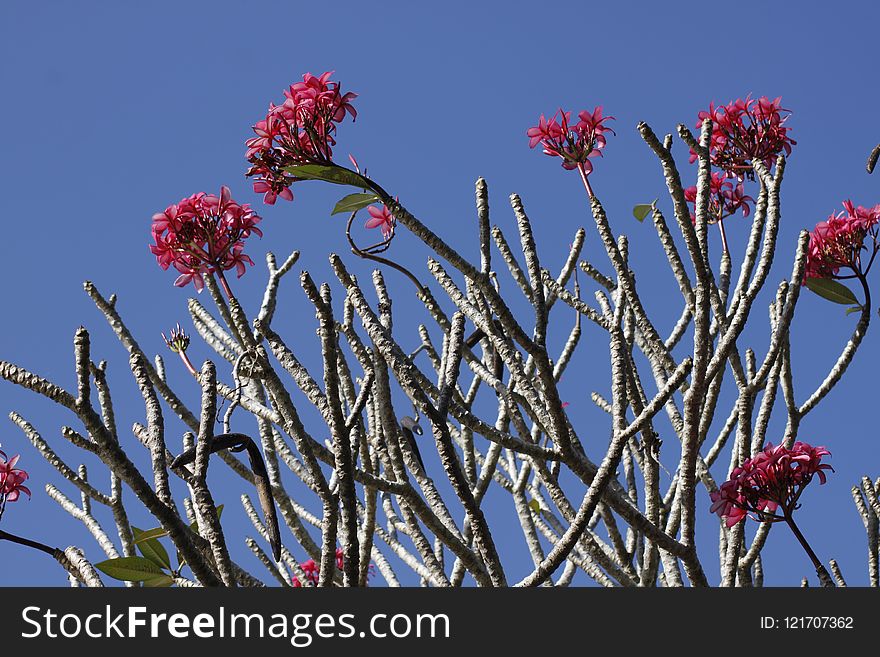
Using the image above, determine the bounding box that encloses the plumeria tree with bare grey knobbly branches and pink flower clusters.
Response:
[0,72,880,587]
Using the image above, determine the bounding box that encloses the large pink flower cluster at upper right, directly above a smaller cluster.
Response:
[690,95,797,178]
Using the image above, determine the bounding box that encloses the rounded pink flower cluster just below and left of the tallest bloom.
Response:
[150,186,263,291]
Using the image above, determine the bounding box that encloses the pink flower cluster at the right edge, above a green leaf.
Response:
[804,201,880,278]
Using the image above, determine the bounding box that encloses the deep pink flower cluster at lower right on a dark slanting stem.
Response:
[710,441,833,527]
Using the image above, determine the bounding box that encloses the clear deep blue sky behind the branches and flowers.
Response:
[0,0,880,585]
